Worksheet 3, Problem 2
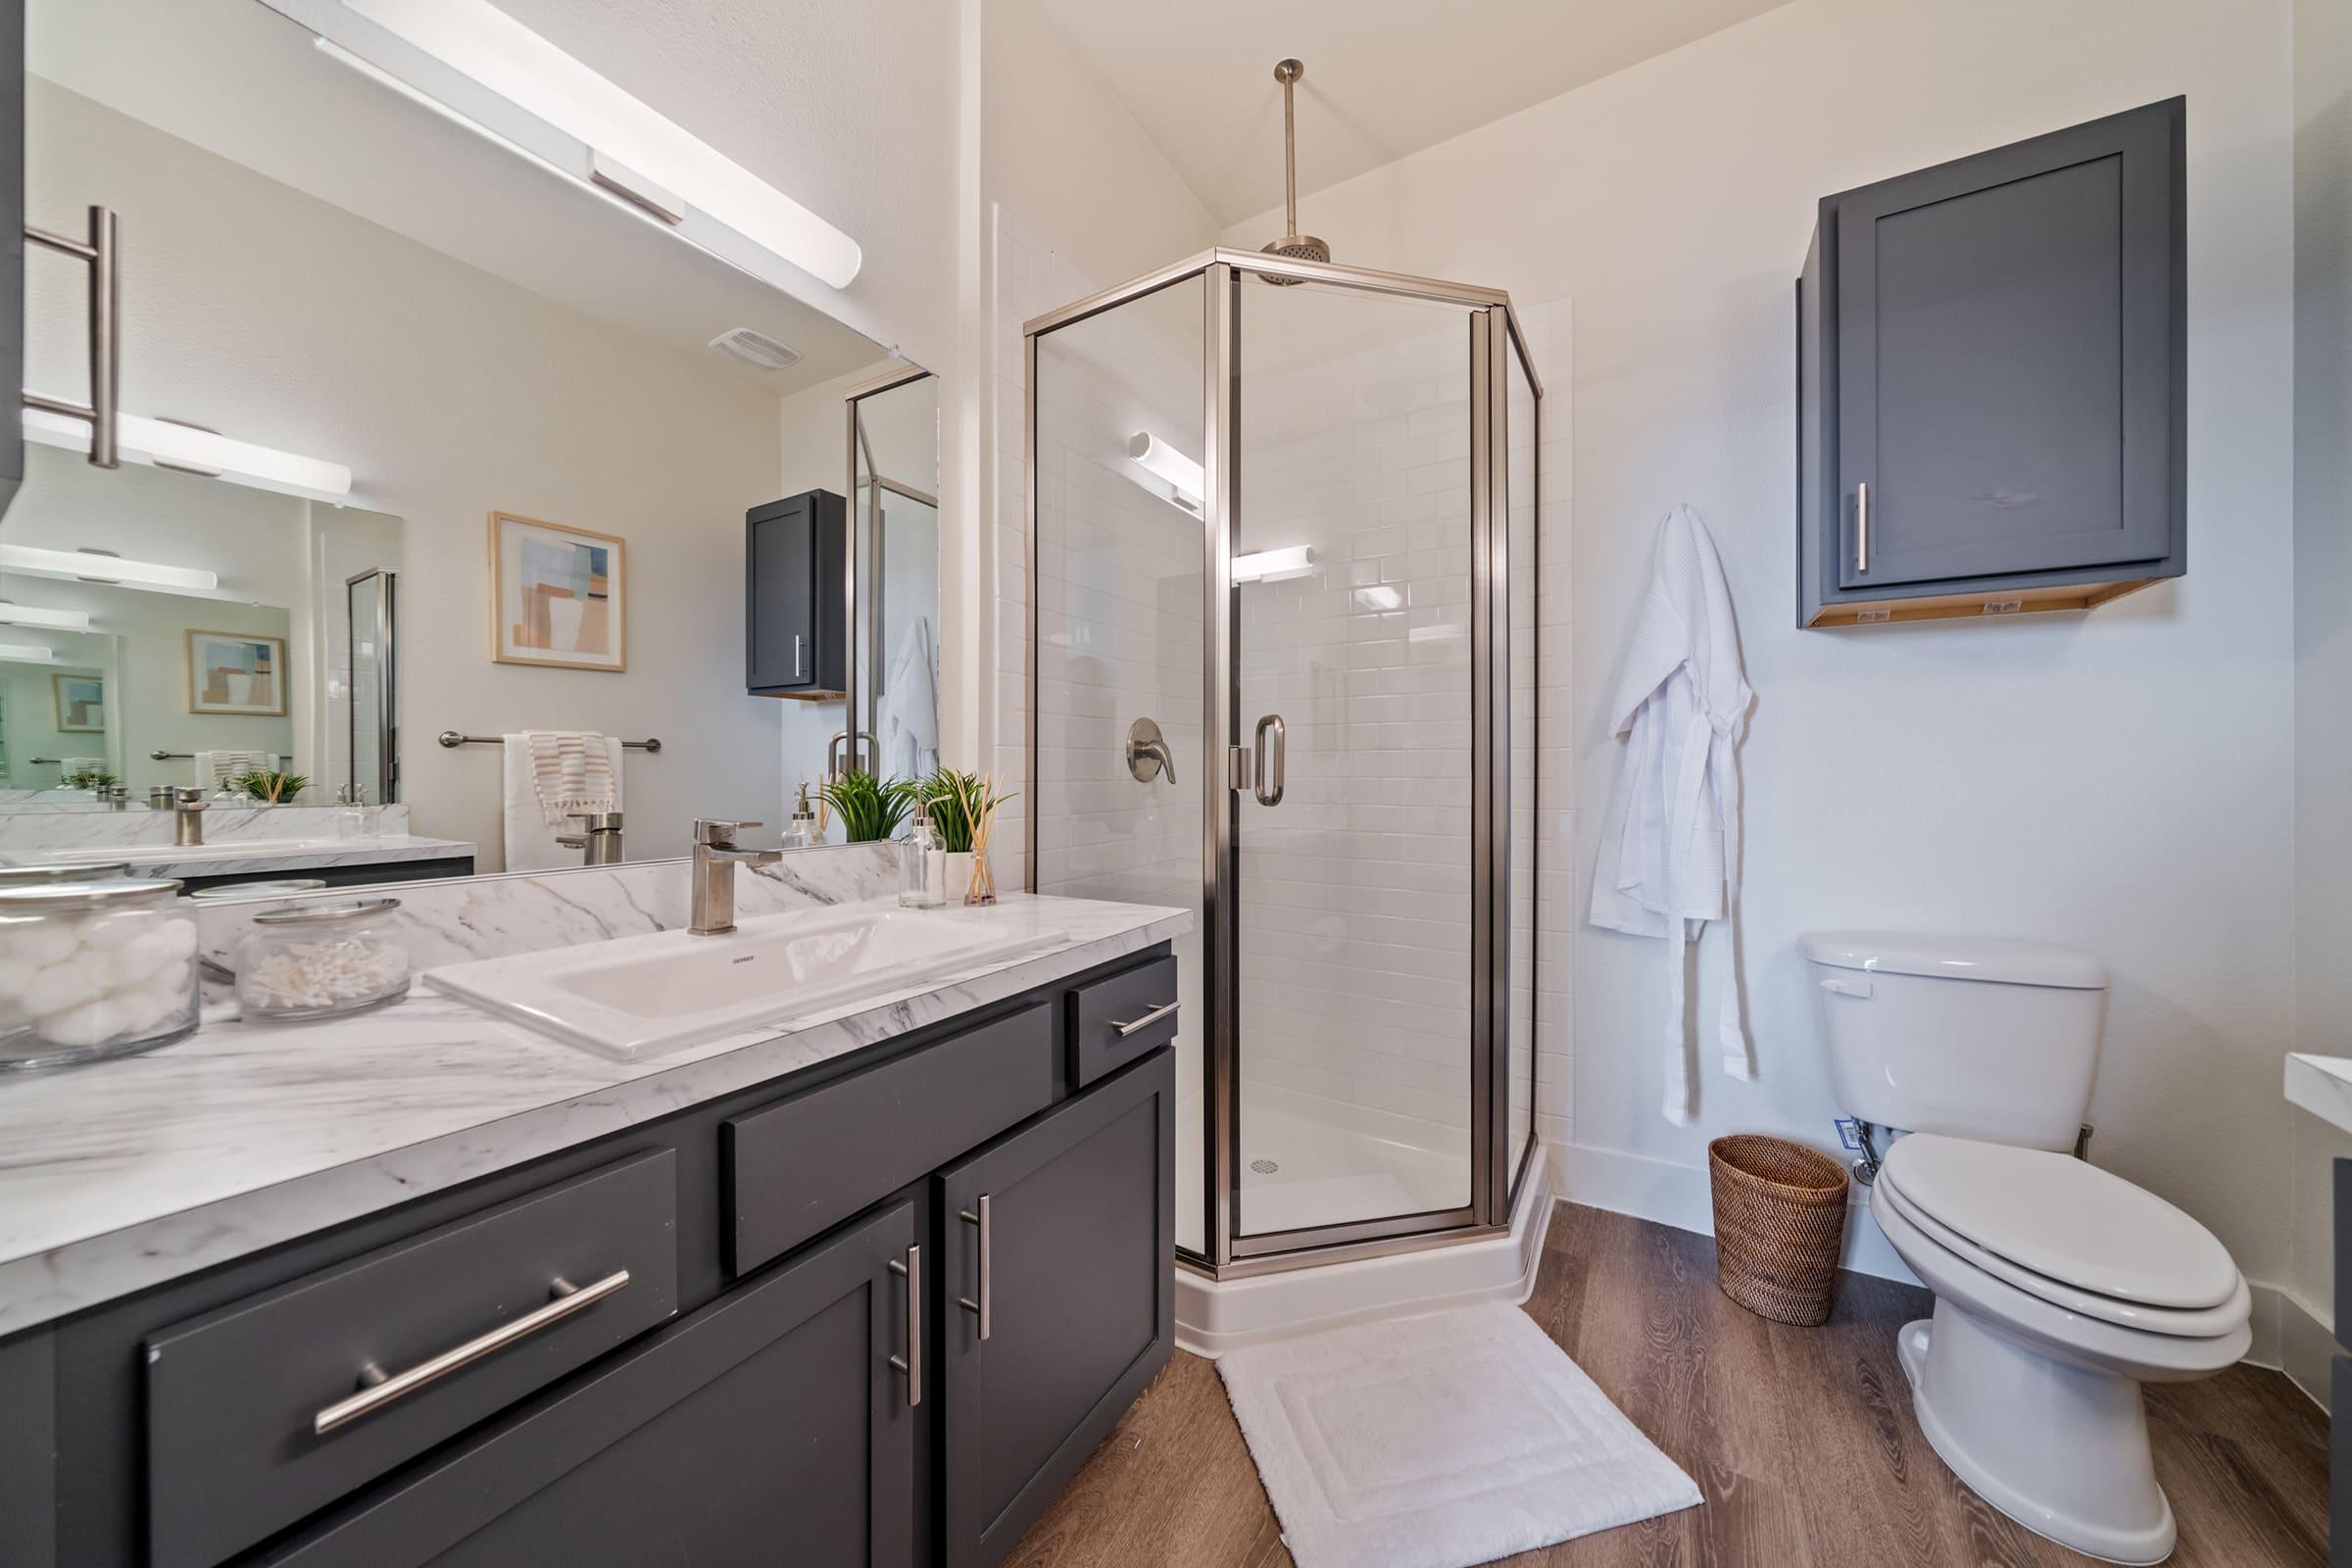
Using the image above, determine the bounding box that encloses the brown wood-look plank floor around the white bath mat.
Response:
[1006,1203,2328,1568]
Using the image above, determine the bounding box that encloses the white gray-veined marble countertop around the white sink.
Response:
[0,894,1193,1336]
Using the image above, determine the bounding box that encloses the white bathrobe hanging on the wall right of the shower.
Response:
[1592,506,1754,1124]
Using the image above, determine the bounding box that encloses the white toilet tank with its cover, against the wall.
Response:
[1797,931,2107,1150]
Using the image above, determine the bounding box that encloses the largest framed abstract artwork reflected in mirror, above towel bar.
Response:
[489,513,628,670]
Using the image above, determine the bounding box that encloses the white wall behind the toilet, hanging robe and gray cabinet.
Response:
[1230,0,2293,1281]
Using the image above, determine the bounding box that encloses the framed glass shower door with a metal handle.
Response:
[1223,277,1487,1255]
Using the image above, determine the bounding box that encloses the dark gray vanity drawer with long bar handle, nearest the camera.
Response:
[146,1150,677,1568]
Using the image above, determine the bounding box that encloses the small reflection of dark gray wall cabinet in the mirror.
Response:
[743,489,849,698]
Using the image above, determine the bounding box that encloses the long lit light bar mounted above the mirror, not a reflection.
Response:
[343,0,865,289]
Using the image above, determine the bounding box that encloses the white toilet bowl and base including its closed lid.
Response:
[1870,1133,2251,1563]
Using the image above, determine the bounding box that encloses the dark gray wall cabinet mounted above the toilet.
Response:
[1797,99,2187,625]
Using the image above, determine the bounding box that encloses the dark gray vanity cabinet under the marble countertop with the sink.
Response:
[0,943,1176,1568]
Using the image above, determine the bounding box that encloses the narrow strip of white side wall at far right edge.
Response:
[2286,0,2352,1403]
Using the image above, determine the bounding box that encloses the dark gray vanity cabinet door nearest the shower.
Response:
[939,1049,1176,1568]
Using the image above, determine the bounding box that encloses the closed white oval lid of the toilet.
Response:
[1880,1133,2239,1309]
